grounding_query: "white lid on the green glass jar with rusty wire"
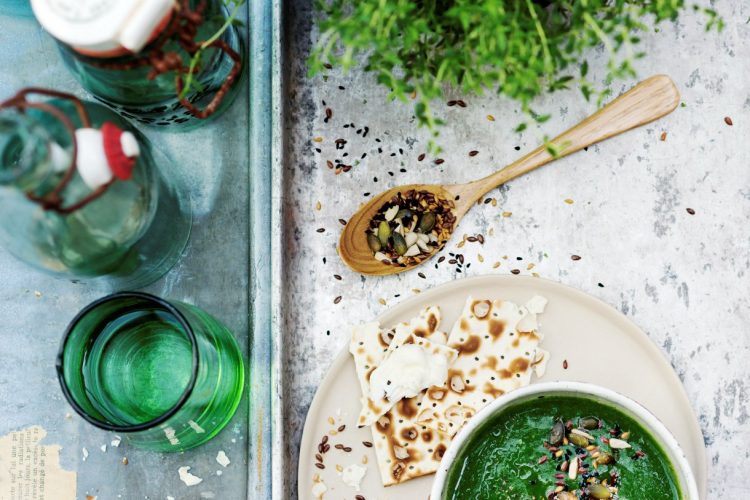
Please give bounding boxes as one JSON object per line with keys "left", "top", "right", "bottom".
{"left": 31, "top": 0, "right": 174, "bottom": 52}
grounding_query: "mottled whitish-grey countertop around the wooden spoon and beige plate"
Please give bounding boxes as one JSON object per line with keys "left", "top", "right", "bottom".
{"left": 282, "top": 0, "right": 750, "bottom": 499}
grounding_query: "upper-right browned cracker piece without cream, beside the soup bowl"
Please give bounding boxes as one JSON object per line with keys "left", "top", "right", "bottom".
{"left": 417, "top": 297, "right": 549, "bottom": 437}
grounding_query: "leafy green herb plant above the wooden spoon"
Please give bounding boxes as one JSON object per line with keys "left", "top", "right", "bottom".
{"left": 309, "top": 0, "right": 723, "bottom": 148}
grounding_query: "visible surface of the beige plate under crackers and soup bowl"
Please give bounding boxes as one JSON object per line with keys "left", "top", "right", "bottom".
{"left": 298, "top": 275, "right": 707, "bottom": 500}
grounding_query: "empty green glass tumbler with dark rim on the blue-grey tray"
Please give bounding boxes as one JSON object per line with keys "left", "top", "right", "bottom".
{"left": 57, "top": 292, "right": 244, "bottom": 451}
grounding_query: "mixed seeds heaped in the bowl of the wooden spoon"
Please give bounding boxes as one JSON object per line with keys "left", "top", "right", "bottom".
{"left": 366, "top": 189, "right": 456, "bottom": 267}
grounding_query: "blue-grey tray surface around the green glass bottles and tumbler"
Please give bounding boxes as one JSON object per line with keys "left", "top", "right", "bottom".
{"left": 0, "top": 14, "right": 250, "bottom": 500}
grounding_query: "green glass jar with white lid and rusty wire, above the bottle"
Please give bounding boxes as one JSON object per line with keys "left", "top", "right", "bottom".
{"left": 31, "top": 0, "right": 245, "bottom": 130}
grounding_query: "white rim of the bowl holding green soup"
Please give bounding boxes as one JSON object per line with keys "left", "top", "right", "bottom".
{"left": 430, "top": 382, "right": 699, "bottom": 500}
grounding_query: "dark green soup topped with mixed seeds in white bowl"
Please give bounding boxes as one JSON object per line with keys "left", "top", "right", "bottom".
{"left": 443, "top": 395, "right": 683, "bottom": 500}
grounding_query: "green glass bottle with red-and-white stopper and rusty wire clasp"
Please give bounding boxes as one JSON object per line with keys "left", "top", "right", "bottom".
{"left": 0, "top": 89, "right": 191, "bottom": 290}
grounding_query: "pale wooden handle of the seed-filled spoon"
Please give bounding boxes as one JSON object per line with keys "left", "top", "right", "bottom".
{"left": 476, "top": 75, "right": 680, "bottom": 200}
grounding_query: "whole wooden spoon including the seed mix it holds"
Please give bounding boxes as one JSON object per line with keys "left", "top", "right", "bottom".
{"left": 339, "top": 75, "right": 680, "bottom": 275}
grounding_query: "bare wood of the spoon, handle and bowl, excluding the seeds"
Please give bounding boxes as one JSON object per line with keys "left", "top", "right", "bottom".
{"left": 339, "top": 75, "right": 680, "bottom": 275}
